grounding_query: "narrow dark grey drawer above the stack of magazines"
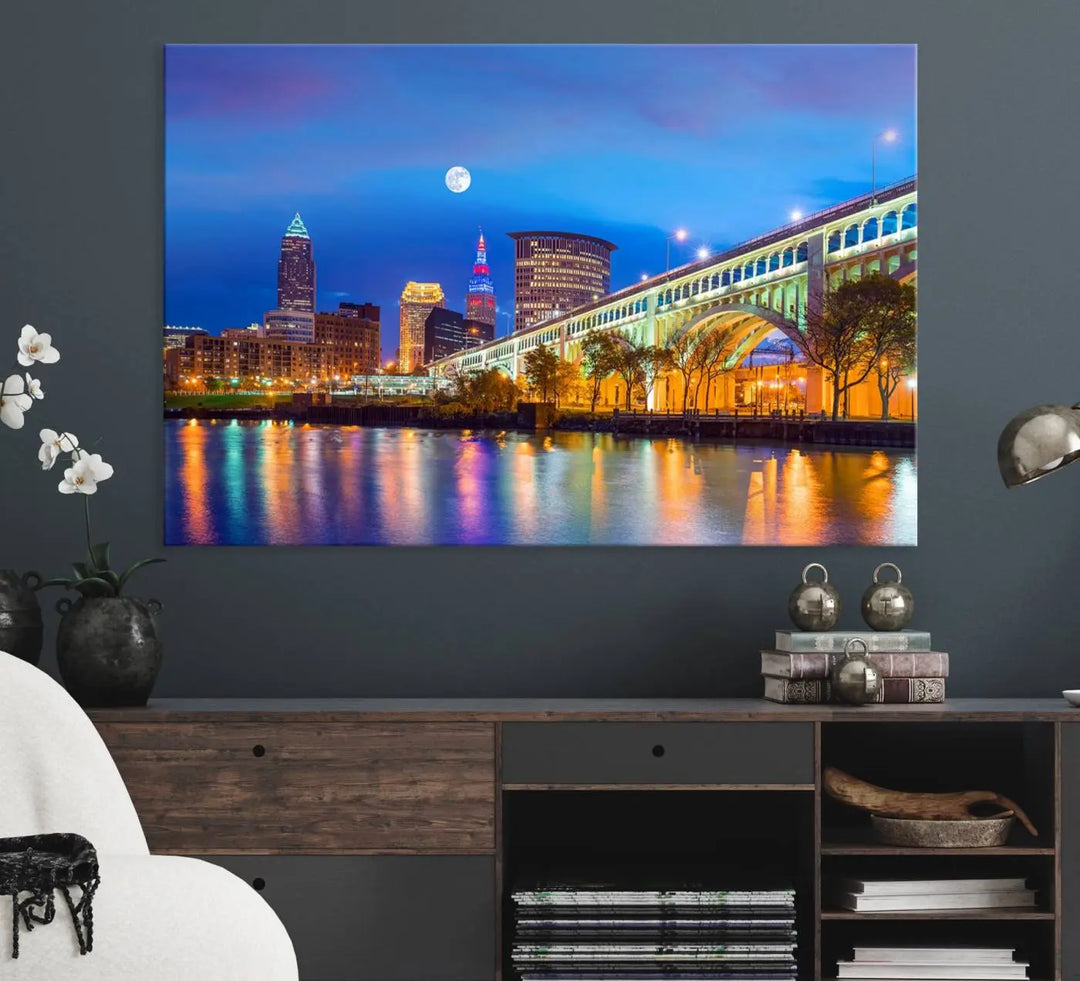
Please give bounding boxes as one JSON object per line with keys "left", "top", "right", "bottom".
{"left": 502, "top": 722, "right": 814, "bottom": 787}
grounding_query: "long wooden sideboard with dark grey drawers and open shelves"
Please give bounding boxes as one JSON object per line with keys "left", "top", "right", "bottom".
{"left": 91, "top": 699, "right": 1080, "bottom": 981}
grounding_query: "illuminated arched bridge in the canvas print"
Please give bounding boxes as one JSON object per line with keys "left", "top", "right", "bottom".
{"left": 428, "top": 177, "right": 918, "bottom": 411}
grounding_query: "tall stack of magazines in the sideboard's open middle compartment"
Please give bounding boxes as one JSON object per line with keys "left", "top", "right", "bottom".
{"left": 512, "top": 884, "right": 797, "bottom": 981}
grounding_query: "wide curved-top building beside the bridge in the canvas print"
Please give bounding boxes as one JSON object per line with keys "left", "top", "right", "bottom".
{"left": 509, "top": 231, "right": 619, "bottom": 331}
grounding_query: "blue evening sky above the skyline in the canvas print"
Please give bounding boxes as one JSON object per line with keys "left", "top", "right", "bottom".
{"left": 165, "top": 45, "right": 917, "bottom": 359}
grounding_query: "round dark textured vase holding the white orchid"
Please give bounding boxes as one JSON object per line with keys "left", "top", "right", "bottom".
{"left": 56, "top": 596, "right": 161, "bottom": 708}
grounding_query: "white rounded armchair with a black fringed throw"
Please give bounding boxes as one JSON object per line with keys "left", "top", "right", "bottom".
{"left": 0, "top": 653, "right": 297, "bottom": 981}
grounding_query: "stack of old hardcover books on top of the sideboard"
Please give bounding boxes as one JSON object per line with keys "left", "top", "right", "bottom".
{"left": 761, "top": 630, "right": 948, "bottom": 704}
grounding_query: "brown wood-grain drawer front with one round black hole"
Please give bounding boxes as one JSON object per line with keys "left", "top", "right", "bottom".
{"left": 98, "top": 721, "right": 496, "bottom": 855}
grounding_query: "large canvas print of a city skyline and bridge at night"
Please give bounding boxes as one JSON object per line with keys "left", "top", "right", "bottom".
{"left": 162, "top": 44, "right": 918, "bottom": 546}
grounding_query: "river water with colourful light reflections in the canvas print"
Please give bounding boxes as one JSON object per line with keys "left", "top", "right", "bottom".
{"left": 165, "top": 419, "right": 917, "bottom": 545}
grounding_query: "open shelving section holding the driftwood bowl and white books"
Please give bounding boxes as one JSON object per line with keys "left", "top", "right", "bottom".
{"left": 818, "top": 721, "right": 1057, "bottom": 979}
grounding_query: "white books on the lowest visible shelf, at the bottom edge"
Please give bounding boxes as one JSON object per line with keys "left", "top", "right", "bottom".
{"left": 837, "top": 946, "right": 1029, "bottom": 981}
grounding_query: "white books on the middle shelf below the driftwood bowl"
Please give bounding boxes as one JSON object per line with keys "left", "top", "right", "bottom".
{"left": 828, "top": 877, "right": 1035, "bottom": 913}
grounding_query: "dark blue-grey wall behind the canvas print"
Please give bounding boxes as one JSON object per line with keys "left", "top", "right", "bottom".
{"left": 0, "top": 0, "right": 1080, "bottom": 696}
